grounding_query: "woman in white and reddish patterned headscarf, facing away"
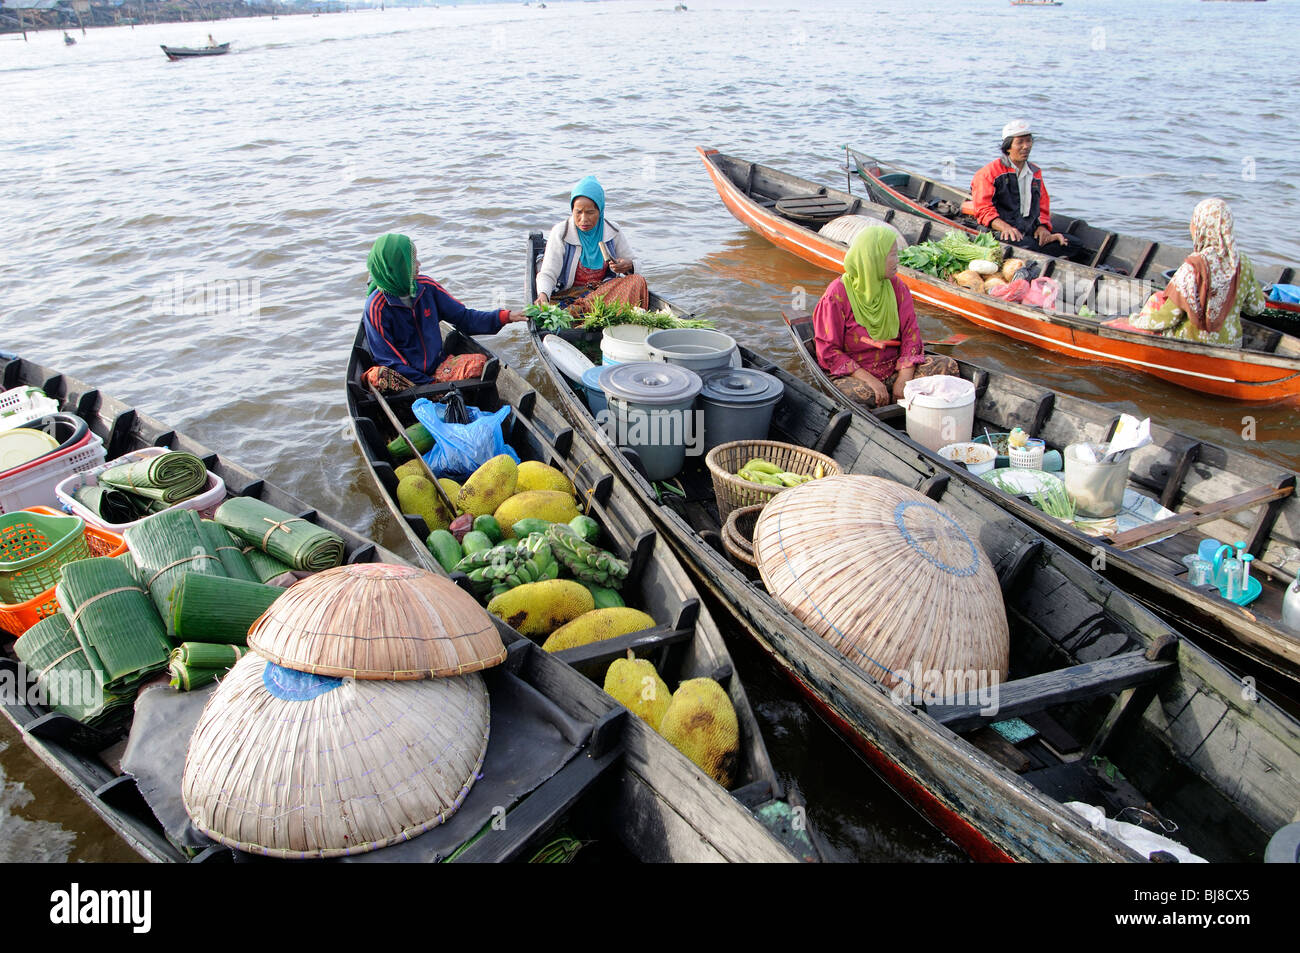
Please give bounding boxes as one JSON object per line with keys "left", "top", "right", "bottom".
{"left": 1121, "top": 199, "right": 1266, "bottom": 347}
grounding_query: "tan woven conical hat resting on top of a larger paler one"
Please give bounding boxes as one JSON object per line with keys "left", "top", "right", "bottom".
{"left": 248, "top": 563, "right": 506, "bottom": 679}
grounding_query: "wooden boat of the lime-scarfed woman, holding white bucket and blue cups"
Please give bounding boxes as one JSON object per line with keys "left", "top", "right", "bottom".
{"left": 785, "top": 316, "right": 1300, "bottom": 696}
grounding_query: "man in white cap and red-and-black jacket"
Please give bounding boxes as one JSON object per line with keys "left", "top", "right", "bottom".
{"left": 971, "top": 120, "right": 1069, "bottom": 255}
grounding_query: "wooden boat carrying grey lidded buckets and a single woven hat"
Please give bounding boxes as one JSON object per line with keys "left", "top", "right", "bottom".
{"left": 512, "top": 233, "right": 1300, "bottom": 861}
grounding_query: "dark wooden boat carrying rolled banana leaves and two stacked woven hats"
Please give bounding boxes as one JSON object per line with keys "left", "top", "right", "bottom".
{"left": 0, "top": 355, "right": 794, "bottom": 862}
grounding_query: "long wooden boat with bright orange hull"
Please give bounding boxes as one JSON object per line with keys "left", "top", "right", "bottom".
{"left": 699, "top": 148, "right": 1300, "bottom": 403}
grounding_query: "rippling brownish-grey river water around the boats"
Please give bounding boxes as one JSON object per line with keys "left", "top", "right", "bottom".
{"left": 0, "top": 0, "right": 1300, "bottom": 861}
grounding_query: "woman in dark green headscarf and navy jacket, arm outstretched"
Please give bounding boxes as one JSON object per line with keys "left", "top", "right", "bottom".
{"left": 361, "top": 234, "right": 525, "bottom": 390}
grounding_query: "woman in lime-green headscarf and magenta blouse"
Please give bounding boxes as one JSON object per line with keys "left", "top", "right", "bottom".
{"left": 813, "top": 225, "right": 958, "bottom": 407}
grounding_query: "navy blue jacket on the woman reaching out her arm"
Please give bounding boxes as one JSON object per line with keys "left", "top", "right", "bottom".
{"left": 363, "top": 274, "right": 510, "bottom": 384}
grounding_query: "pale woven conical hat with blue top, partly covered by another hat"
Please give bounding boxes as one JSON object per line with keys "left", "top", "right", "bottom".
{"left": 181, "top": 655, "right": 488, "bottom": 858}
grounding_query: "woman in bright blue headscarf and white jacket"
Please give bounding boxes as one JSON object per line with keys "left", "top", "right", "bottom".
{"left": 537, "top": 176, "right": 650, "bottom": 313}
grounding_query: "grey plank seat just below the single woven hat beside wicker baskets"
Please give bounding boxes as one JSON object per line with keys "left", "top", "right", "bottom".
{"left": 926, "top": 650, "right": 1175, "bottom": 733}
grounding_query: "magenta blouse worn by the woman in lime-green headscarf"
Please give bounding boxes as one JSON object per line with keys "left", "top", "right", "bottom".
{"left": 813, "top": 276, "right": 926, "bottom": 381}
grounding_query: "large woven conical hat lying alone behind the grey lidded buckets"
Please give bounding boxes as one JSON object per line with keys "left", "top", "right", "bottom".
{"left": 754, "top": 476, "right": 1010, "bottom": 694}
